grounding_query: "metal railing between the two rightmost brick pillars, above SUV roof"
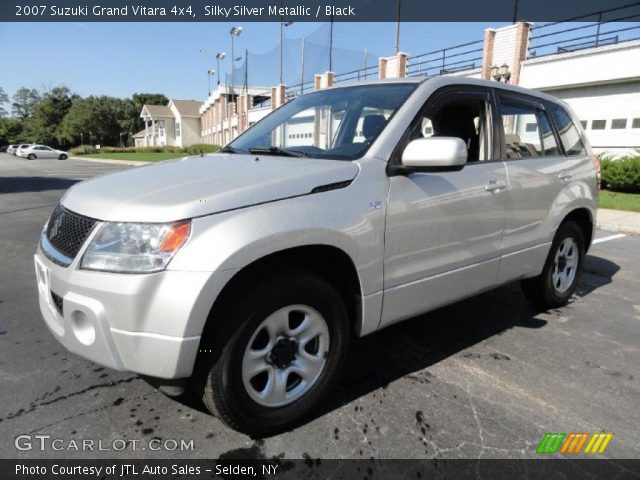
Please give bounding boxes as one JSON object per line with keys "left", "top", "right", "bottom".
{"left": 407, "top": 40, "right": 483, "bottom": 77}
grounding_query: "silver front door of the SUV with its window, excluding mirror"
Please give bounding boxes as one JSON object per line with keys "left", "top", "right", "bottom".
{"left": 381, "top": 87, "right": 508, "bottom": 327}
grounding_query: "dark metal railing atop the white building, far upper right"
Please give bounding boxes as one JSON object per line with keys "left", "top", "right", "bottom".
{"left": 527, "top": 2, "right": 640, "bottom": 58}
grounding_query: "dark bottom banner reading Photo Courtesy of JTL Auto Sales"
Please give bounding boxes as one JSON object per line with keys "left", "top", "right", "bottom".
{"left": 0, "top": 457, "right": 640, "bottom": 480}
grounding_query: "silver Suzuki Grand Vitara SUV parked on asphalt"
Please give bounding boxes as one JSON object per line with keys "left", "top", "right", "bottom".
{"left": 35, "top": 77, "right": 599, "bottom": 435}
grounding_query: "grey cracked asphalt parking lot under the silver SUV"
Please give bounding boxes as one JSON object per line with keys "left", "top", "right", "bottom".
{"left": 0, "top": 154, "right": 640, "bottom": 459}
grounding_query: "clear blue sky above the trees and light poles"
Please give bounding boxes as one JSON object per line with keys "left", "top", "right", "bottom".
{"left": 0, "top": 22, "right": 505, "bottom": 100}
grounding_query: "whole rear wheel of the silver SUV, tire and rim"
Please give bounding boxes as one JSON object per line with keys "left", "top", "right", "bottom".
{"left": 522, "top": 221, "right": 585, "bottom": 309}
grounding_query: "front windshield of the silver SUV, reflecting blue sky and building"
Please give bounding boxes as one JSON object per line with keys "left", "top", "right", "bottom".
{"left": 228, "top": 83, "right": 416, "bottom": 160}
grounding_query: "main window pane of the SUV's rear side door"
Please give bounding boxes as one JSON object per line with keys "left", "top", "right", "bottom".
{"left": 500, "top": 99, "right": 553, "bottom": 159}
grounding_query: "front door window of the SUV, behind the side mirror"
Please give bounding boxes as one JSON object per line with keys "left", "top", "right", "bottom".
{"left": 409, "top": 93, "right": 489, "bottom": 162}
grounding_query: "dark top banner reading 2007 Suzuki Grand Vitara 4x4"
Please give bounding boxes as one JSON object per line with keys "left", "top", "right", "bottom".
{"left": 0, "top": 0, "right": 640, "bottom": 22}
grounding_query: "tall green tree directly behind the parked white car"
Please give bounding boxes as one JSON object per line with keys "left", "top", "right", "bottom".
{"left": 25, "top": 86, "right": 79, "bottom": 146}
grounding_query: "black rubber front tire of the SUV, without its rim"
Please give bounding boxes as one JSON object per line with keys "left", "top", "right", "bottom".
{"left": 195, "top": 271, "right": 350, "bottom": 437}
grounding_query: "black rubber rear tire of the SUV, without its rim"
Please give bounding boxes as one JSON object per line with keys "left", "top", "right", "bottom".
{"left": 522, "top": 220, "right": 585, "bottom": 310}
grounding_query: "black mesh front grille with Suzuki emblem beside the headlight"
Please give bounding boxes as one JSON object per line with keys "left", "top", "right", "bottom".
{"left": 46, "top": 205, "right": 96, "bottom": 259}
